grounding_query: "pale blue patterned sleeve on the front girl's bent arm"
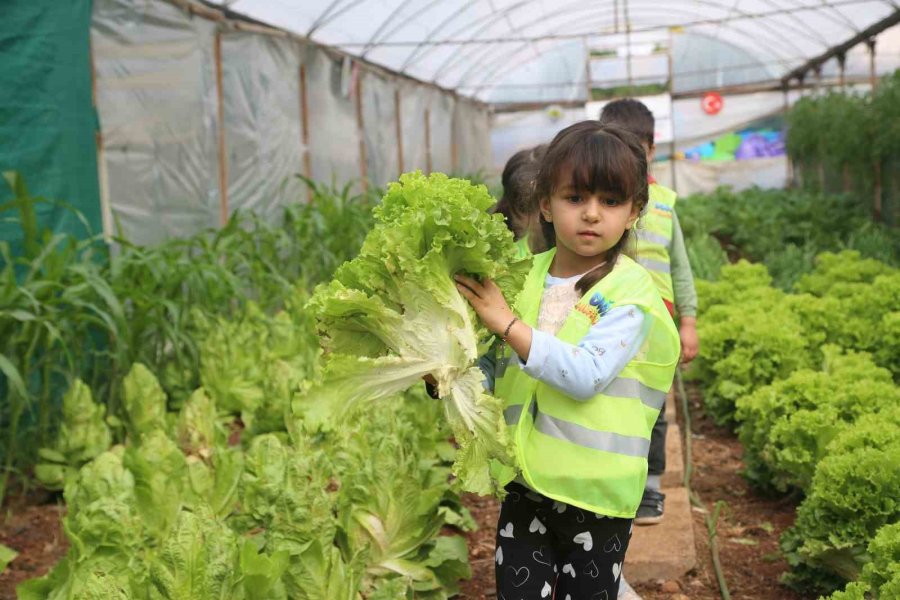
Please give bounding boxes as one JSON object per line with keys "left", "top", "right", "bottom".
{"left": 519, "top": 305, "right": 649, "bottom": 400}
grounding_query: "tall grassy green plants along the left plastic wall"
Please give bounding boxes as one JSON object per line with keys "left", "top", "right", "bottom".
{"left": 0, "top": 170, "right": 378, "bottom": 502}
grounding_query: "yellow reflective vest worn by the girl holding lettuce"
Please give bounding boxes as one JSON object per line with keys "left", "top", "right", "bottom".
{"left": 495, "top": 248, "right": 680, "bottom": 518}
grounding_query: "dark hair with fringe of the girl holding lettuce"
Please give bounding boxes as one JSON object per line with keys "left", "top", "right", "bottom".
{"left": 535, "top": 121, "right": 649, "bottom": 294}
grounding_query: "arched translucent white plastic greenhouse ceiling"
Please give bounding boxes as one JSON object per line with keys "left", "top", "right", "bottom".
{"left": 209, "top": 0, "right": 900, "bottom": 101}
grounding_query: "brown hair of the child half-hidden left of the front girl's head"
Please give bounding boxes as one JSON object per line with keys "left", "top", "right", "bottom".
{"left": 494, "top": 144, "right": 547, "bottom": 239}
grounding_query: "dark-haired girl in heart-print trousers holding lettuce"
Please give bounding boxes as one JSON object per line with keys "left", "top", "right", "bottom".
{"left": 456, "top": 121, "right": 679, "bottom": 600}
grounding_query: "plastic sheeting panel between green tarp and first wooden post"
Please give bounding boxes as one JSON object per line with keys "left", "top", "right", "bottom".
{"left": 91, "top": 0, "right": 220, "bottom": 244}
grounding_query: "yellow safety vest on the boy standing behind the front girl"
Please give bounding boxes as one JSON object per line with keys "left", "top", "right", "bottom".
{"left": 634, "top": 183, "right": 677, "bottom": 304}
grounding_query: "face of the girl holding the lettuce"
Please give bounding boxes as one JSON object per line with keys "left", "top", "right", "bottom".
{"left": 541, "top": 184, "right": 639, "bottom": 264}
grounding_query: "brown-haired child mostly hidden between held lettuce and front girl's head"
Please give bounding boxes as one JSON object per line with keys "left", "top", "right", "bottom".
{"left": 494, "top": 144, "right": 547, "bottom": 257}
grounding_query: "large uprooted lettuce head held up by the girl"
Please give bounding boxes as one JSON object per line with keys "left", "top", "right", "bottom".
{"left": 293, "top": 172, "right": 529, "bottom": 494}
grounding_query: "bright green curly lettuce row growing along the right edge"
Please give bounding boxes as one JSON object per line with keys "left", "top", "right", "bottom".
{"left": 690, "top": 250, "right": 900, "bottom": 599}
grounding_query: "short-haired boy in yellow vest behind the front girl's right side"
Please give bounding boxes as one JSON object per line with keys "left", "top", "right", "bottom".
{"left": 600, "top": 98, "right": 700, "bottom": 525}
